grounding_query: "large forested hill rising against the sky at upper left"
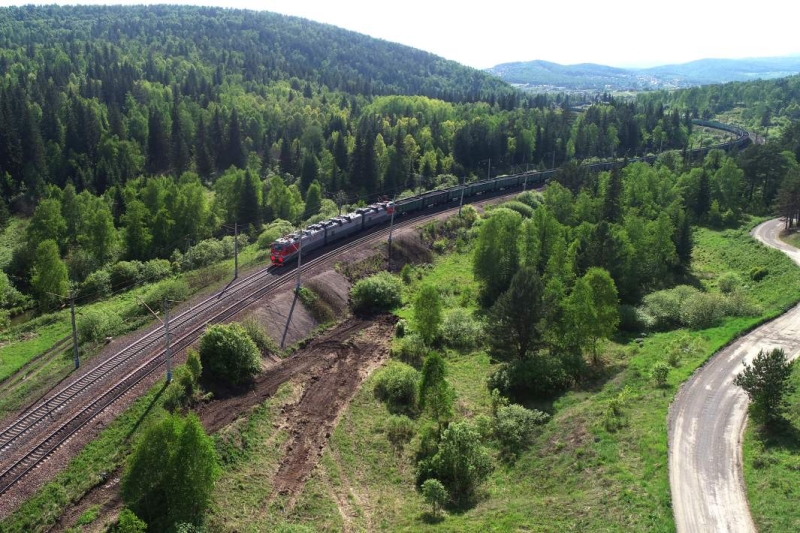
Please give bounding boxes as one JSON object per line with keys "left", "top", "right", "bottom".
{"left": 0, "top": 6, "right": 513, "bottom": 101}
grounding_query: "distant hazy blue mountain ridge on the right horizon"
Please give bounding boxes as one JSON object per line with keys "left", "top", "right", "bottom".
{"left": 486, "top": 56, "right": 800, "bottom": 90}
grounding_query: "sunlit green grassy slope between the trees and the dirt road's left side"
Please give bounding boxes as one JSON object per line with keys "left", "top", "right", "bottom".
{"left": 270, "top": 222, "right": 800, "bottom": 531}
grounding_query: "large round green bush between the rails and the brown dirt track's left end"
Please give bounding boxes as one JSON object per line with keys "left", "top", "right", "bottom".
{"left": 200, "top": 324, "right": 261, "bottom": 385}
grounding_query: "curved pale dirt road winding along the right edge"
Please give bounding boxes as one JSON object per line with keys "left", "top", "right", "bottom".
{"left": 668, "top": 220, "right": 800, "bottom": 533}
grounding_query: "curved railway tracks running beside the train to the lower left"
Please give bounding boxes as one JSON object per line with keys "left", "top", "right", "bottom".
{"left": 0, "top": 119, "right": 749, "bottom": 502}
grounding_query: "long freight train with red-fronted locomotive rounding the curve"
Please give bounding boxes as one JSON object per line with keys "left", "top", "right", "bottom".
{"left": 270, "top": 120, "right": 750, "bottom": 266}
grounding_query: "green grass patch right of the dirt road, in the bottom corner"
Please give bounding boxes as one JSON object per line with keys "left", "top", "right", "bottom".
{"left": 743, "top": 364, "right": 800, "bottom": 533}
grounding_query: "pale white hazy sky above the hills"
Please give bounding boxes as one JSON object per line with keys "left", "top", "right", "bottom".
{"left": 0, "top": 0, "right": 800, "bottom": 68}
